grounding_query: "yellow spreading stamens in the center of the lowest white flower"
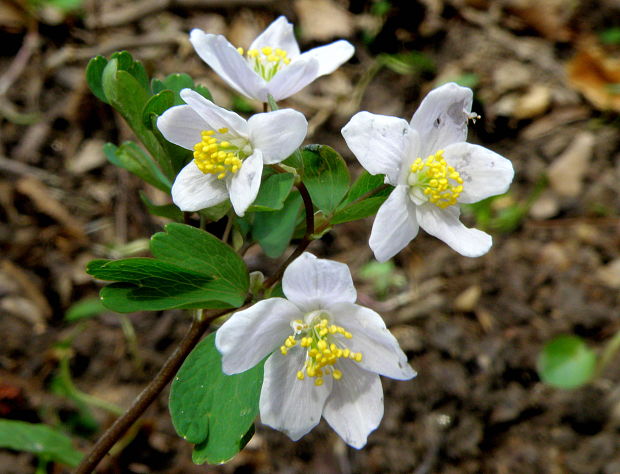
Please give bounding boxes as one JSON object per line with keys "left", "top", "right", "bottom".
{"left": 280, "top": 311, "right": 362, "bottom": 385}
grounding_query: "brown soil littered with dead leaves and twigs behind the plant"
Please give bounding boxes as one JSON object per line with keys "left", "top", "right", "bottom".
{"left": 0, "top": 0, "right": 620, "bottom": 474}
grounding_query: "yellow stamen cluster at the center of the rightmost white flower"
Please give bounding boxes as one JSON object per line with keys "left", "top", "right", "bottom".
{"left": 407, "top": 150, "right": 463, "bottom": 209}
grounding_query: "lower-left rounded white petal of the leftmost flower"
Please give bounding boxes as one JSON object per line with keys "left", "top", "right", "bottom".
{"left": 172, "top": 160, "right": 228, "bottom": 212}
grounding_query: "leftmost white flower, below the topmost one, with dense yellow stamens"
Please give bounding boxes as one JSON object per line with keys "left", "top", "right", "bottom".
{"left": 157, "top": 89, "right": 308, "bottom": 216}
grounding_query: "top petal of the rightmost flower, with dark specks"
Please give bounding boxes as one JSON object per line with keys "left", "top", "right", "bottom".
{"left": 411, "top": 82, "right": 473, "bottom": 158}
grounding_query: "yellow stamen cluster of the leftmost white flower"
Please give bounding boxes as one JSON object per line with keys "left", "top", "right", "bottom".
{"left": 194, "top": 128, "right": 245, "bottom": 179}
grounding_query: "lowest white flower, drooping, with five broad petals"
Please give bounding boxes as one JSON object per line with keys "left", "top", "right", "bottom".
{"left": 215, "top": 253, "right": 415, "bottom": 449}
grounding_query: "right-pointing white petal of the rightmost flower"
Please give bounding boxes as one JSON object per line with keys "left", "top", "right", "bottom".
{"left": 444, "top": 142, "right": 515, "bottom": 203}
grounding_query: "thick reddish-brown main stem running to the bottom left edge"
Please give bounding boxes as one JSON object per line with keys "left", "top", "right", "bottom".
{"left": 75, "top": 309, "right": 231, "bottom": 474}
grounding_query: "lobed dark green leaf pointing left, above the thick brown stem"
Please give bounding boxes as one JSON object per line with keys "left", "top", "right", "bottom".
{"left": 86, "top": 223, "right": 249, "bottom": 313}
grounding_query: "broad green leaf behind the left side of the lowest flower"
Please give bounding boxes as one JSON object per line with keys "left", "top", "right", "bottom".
{"left": 169, "top": 334, "right": 263, "bottom": 464}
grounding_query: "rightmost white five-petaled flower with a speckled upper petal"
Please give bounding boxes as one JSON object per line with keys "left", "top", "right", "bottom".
{"left": 342, "top": 83, "right": 514, "bottom": 262}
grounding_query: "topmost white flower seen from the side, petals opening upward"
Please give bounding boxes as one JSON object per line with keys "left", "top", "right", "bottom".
{"left": 190, "top": 16, "right": 355, "bottom": 102}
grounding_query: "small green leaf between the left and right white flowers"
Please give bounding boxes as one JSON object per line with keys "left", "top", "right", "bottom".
{"left": 301, "top": 145, "right": 349, "bottom": 214}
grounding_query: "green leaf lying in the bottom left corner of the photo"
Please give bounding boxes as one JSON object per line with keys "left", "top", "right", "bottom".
{"left": 0, "top": 420, "right": 83, "bottom": 467}
